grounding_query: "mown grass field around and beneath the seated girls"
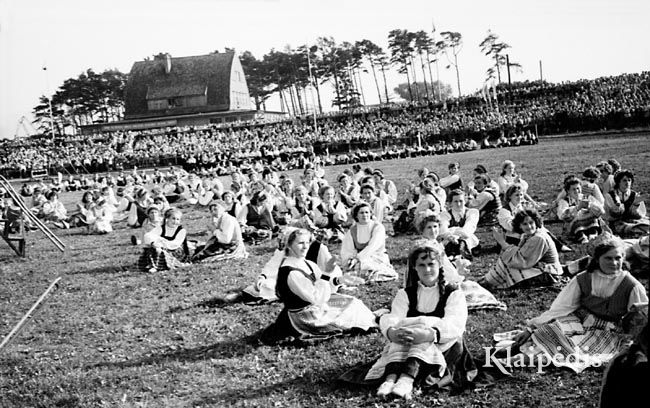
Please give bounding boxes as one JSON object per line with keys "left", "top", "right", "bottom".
{"left": 0, "top": 133, "right": 650, "bottom": 408}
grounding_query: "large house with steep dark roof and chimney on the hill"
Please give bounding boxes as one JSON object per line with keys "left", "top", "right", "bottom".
{"left": 82, "top": 52, "right": 285, "bottom": 133}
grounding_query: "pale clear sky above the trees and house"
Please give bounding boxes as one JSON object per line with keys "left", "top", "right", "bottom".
{"left": 0, "top": 0, "right": 650, "bottom": 138}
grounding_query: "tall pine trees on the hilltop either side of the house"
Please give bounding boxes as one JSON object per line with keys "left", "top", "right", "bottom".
{"left": 33, "top": 28, "right": 521, "bottom": 134}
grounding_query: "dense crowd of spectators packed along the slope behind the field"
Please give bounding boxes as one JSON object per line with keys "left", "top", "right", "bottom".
{"left": 0, "top": 72, "right": 650, "bottom": 177}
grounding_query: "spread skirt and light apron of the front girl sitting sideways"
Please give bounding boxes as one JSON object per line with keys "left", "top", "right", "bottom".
{"left": 261, "top": 293, "right": 377, "bottom": 344}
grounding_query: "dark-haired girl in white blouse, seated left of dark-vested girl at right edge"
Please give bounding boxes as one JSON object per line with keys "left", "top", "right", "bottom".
{"left": 557, "top": 176, "right": 605, "bottom": 244}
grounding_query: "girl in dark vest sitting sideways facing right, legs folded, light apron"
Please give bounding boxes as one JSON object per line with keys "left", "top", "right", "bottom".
{"left": 261, "top": 229, "right": 377, "bottom": 343}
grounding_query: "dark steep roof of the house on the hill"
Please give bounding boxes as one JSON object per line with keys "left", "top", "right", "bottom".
{"left": 124, "top": 52, "right": 235, "bottom": 119}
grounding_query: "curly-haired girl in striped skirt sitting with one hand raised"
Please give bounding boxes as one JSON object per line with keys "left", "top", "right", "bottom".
{"left": 479, "top": 209, "right": 563, "bottom": 289}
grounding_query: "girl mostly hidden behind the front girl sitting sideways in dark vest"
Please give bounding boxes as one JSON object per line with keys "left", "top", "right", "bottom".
{"left": 243, "top": 227, "right": 344, "bottom": 302}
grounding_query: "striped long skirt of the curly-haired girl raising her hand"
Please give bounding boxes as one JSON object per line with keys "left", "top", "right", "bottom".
{"left": 479, "top": 257, "right": 562, "bottom": 289}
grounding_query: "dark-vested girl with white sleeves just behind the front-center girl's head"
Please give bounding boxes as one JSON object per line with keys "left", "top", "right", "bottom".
{"left": 440, "top": 190, "right": 479, "bottom": 260}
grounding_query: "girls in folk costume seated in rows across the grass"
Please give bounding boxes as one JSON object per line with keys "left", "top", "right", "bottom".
{"left": 3, "top": 154, "right": 650, "bottom": 399}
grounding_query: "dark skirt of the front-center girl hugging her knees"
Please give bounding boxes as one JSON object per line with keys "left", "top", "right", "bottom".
{"left": 338, "top": 339, "right": 478, "bottom": 391}
